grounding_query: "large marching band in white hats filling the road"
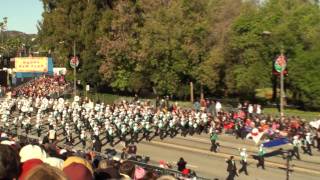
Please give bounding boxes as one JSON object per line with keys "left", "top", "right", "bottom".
{"left": 1, "top": 97, "right": 212, "bottom": 150}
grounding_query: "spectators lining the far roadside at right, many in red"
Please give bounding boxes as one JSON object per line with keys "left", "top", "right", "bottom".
{"left": 194, "top": 100, "right": 320, "bottom": 151}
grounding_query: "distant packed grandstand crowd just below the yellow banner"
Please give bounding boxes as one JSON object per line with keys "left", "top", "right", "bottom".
{"left": 12, "top": 75, "right": 68, "bottom": 97}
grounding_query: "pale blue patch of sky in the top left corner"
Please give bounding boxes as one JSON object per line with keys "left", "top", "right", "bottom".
{"left": 0, "top": 0, "right": 43, "bottom": 34}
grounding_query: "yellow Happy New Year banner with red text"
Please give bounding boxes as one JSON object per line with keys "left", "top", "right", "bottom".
{"left": 15, "top": 57, "right": 48, "bottom": 73}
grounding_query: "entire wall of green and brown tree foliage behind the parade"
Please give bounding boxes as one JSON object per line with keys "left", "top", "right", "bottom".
{"left": 39, "top": 0, "right": 320, "bottom": 107}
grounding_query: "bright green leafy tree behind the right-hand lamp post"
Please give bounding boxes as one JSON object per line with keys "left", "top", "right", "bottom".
{"left": 226, "top": 0, "right": 320, "bottom": 105}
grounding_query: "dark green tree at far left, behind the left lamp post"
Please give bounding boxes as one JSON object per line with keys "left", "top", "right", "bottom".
{"left": 39, "top": 0, "right": 108, "bottom": 88}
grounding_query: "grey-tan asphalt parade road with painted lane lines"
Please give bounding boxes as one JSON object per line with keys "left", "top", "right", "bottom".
{"left": 0, "top": 109, "right": 320, "bottom": 180}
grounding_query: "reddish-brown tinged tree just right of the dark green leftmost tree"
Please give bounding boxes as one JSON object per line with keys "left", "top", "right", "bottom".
{"left": 98, "top": 1, "right": 146, "bottom": 91}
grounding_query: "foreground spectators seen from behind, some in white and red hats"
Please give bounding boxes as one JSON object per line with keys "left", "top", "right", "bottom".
{"left": 0, "top": 132, "right": 198, "bottom": 180}
